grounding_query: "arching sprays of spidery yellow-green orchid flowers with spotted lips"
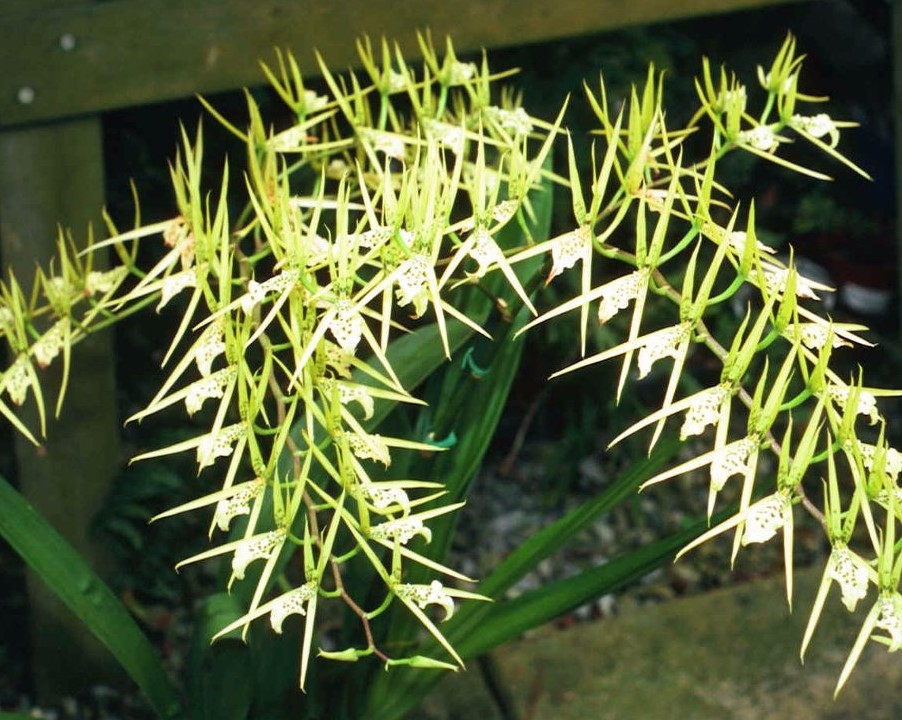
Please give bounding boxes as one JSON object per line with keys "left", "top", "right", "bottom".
{"left": 0, "top": 36, "right": 902, "bottom": 690}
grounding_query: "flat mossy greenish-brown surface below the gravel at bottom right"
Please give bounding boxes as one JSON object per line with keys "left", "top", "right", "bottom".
{"left": 409, "top": 569, "right": 902, "bottom": 720}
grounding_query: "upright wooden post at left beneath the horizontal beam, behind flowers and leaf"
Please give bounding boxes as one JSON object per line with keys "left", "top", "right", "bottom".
{"left": 0, "top": 28, "right": 120, "bottom": 702}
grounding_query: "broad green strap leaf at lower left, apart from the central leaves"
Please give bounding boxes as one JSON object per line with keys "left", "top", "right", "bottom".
{"left": 0, "top": 477, "right": 181, "bottom": 718}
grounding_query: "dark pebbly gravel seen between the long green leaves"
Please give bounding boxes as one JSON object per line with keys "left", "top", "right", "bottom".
{"left": 455, "top": 434, "right": 827, "bottom": 624}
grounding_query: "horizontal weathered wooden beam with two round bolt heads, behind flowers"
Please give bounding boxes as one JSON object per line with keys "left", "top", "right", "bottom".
{"left": 0, "top": 0, "right": 803, "bottom": 127}
